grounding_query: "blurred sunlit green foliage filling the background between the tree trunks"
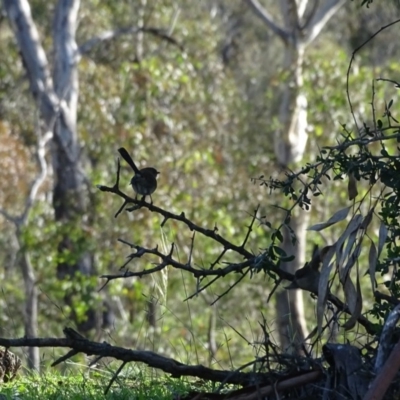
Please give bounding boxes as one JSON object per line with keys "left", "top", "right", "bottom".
{"left": 0, "top": 1, "right": 400, "bottom": 376}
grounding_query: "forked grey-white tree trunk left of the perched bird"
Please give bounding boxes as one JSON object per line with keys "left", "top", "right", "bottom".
{"left": 3, "top": 0, "right": 99, "bottom": 338}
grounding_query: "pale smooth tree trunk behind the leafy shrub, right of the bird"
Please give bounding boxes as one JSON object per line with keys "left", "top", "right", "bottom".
{"left": 245, "top": 0, "right": 345, "bottom": 350}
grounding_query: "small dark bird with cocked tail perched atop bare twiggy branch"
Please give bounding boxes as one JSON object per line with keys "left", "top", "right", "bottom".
{"left": 118, "top": 147, "right": 159, "bottom": 201}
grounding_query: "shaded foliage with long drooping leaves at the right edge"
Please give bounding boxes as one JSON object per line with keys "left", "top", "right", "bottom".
{"left": 265, "top": 81, "right": 400, "bottom": 333}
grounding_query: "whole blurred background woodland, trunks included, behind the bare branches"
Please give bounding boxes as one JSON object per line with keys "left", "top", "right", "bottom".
{"left": 0, "top": 0, "right": 400, "bottom": 378}
